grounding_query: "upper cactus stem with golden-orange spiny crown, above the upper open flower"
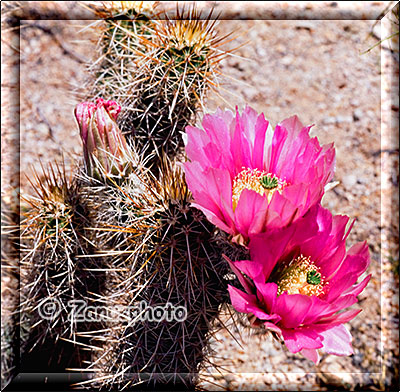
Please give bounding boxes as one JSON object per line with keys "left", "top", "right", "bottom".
{"left": 121, "top": 4, "right": 233, "bottom": 170}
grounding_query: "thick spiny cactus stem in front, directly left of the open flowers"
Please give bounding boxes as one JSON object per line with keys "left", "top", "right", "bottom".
{"left": 77, "top": 157, "right": 236, "bottom": 389}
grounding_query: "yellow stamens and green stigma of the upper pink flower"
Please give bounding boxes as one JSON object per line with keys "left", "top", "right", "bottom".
{"left": 232, "top": 168, "right": 287, "bottom": 211}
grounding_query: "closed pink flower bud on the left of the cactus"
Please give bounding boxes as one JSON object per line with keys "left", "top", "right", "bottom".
{"left": 75, "top": 98, "right": 127, "bottom": 178}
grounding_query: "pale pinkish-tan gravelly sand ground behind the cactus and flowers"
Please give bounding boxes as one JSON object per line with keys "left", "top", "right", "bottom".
{"left": 1, "top": 1, "right": 399, "bottom": 390}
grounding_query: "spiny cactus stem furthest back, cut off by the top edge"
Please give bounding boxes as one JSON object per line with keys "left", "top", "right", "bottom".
{"left": 83, "top": 1, "right": 157, "bottom": 101}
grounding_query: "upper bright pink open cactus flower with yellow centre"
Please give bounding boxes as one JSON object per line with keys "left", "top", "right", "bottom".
{"left": 184, "top": 106, "right": 335, "bottom": 241}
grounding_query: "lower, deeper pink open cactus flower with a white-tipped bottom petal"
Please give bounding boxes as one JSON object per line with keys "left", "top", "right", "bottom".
{"left": 227, "top": 205, "right": 370, "bottom": 363}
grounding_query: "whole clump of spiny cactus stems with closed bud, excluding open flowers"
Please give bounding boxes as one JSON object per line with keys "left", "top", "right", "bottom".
{"left": 15, "top": 2, "right": 239, "bottom": 390}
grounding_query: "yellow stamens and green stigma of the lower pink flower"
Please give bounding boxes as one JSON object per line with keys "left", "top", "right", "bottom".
{"left": 277, "top": 255, "right": 328, "bottom": 297}
